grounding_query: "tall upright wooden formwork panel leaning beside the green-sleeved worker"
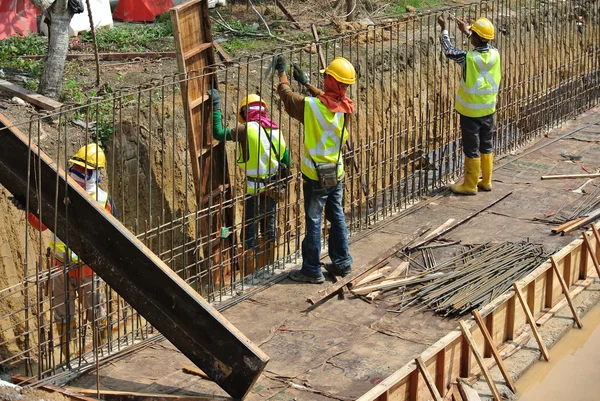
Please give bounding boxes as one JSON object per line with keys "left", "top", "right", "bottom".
{"left": 171, "top": 0, "right": 235, "bottom": 285}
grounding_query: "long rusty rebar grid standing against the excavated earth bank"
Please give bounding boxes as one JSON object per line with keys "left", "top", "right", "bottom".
{"left": 0, "top": 0, "right": 600, "bottom": 380}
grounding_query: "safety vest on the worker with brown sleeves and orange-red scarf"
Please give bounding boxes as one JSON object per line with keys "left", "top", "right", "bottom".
{"left": 301, "top": 97, "right": 348, "bottom": 181}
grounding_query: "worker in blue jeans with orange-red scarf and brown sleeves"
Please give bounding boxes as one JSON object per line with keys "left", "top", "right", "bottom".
{"left": 274, "top": 56, "right": 356, "bottom": 284}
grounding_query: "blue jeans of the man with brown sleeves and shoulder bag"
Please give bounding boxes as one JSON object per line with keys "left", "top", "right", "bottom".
{"left": 302, "top": 178, "right": 352, "bottom": 277}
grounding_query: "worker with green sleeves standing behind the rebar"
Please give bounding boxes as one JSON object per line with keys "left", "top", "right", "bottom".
{"left": 208, "top": 89, "right": 291, "bottom": 275}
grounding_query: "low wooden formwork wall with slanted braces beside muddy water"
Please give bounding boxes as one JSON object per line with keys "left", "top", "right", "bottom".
{"left": 358, "top": 234, "right": 600, "bottom": 401}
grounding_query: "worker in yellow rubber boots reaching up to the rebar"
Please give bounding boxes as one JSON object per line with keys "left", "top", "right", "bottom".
{"left": 438, "top": 16, "right": 501, "bottom": 195}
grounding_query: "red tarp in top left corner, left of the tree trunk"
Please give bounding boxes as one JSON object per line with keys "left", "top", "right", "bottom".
{"left": 0, "top": 0, "right": 40, "bottom": 39}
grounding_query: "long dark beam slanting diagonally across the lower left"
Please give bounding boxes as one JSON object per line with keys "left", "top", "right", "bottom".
{"left": 0, "top": 115, "right": 269, "bottom": 398}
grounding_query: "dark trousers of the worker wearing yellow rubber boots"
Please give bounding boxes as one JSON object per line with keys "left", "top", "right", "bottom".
{"left": 460, "top": 114, "right": 494, "bottom": 159}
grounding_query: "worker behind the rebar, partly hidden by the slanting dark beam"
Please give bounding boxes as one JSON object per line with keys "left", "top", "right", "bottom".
{"left": 11, "top": 143, "right": 118, "bottom": 362}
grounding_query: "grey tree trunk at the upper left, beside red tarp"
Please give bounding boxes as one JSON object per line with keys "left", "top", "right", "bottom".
{"left": 38, "top": 0, "right": 73, "bottom": 99}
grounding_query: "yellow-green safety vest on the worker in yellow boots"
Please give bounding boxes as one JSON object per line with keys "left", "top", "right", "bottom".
{"left": 455, "top": 48, "right": 502, "bottom": 117}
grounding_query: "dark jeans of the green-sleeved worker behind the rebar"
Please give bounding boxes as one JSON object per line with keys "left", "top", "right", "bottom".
{"left": 244, "top": 193, "right": 277, "bottom": 249}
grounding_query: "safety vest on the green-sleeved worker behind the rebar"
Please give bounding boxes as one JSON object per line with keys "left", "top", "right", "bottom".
{"left": 237, "top": 121, "right": 286, "bottom": 194}
